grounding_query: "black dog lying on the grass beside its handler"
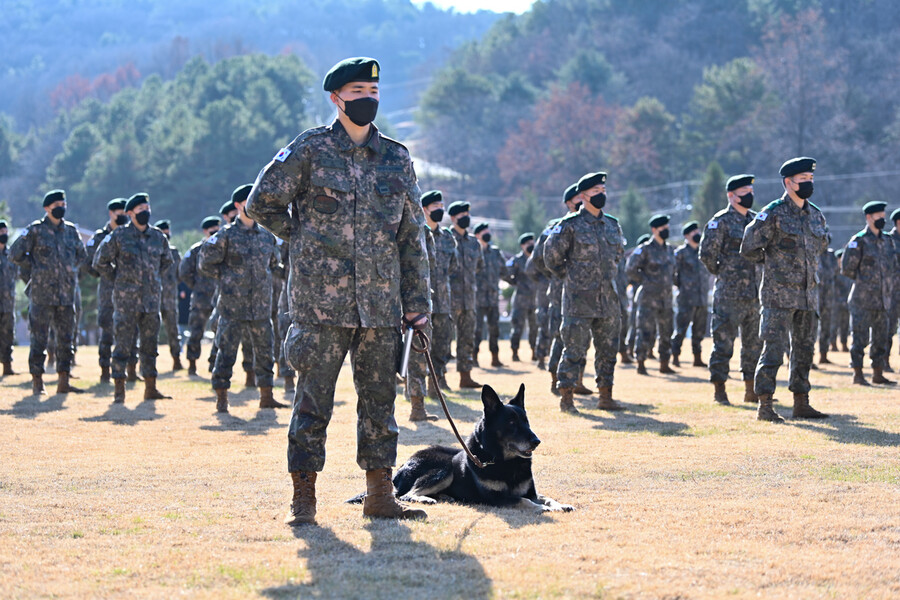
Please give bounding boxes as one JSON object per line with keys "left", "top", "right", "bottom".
{"left": 349, "top": 384, "right": 574, "bottom": 512}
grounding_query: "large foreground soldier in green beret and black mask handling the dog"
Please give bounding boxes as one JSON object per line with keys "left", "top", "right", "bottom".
{"left": 247, "top": 58, "right": 430, "bottom": 525}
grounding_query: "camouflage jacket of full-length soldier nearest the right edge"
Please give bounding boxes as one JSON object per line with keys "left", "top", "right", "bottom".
{"left": 841, "top": 227, "right": 897, "bottom": 310}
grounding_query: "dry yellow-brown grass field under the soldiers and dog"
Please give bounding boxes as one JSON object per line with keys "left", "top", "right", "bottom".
{"left": 0, "top": 340, "right": 900, "bottom": 599}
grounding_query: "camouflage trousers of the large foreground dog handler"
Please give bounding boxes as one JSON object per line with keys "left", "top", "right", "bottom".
{"left": 284, "top": 322, "right": 400, "bottom": 472}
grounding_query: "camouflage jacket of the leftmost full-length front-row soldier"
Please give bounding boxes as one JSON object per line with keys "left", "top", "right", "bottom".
{"left": 9, "top": 216, "right": 86, "bottom": 306}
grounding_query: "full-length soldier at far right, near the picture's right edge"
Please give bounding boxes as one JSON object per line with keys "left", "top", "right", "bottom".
{"left": 841, "top": 202, "right": 897, "bottom": 386}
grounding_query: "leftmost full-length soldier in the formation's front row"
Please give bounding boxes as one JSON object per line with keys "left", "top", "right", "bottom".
{"left": 9, "top": 190, "right": 86, "bottom": 395}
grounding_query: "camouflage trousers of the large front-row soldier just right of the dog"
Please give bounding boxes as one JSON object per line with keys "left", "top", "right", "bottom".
{"left": 556, "top": 311, "right": 621, "bottom": 389}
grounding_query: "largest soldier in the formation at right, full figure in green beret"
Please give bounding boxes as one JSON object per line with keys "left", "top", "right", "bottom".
{"left": 741, "top": 157, "right": 828, "bottom": 423}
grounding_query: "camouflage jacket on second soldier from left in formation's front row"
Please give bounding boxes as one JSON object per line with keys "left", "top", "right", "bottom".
{"left": 92, "top": 223, "right": 172, "bottom": 313}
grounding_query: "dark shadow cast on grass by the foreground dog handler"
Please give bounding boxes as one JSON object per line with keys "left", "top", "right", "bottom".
{"left": 260, "top": 519, "right": 491, "bottom": 599}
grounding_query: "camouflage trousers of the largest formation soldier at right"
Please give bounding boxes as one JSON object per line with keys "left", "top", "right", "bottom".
{"left": 753, "top": 308, "right": 818, "bottom": 394}
